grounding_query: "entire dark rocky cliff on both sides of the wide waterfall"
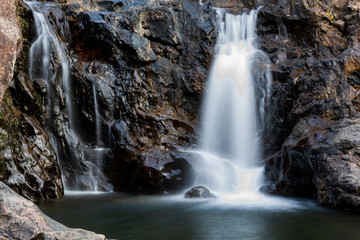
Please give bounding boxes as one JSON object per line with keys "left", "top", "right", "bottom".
{"left": 3, "top": 0, "right": 360, "bottom": 213}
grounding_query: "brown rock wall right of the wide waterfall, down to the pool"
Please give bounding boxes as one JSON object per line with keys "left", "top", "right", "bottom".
{"left": 249, "top": 1, "right": 360, "bottom": 210}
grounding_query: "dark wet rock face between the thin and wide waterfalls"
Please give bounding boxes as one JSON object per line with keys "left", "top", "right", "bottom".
{"left": 59, "top": 1, "right": 216, "bottom": 192}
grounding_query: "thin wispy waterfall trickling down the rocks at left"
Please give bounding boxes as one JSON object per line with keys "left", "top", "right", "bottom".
{"left": 24, "top": 1, "right": 112, "bottom": 192}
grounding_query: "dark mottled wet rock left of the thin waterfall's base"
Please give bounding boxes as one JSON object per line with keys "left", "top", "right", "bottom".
{"left": 0, "top": 91, "right": 64, "bottom": 200}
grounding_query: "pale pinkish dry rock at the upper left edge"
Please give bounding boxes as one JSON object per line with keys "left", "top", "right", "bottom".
{"left": 0, "top": 0, "right": 21, "bottom": 102}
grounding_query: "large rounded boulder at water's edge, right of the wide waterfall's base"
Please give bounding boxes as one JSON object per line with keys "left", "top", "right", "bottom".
{"left": 265, "top": 118, "right": 360, "bottom": 211}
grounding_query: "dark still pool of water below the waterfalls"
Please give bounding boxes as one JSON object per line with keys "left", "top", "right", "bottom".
{"left": 38, "top": 193, "right": 360, "bottom": 240}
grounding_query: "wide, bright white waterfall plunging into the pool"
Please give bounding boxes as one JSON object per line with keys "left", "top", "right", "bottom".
{"left": 196, "top": 9, "right": 271, "bottom": 200}
